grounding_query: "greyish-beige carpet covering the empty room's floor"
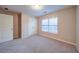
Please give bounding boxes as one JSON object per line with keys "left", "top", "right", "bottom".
{"left": 0, "top": 35, "right": 77, "bottom": 53}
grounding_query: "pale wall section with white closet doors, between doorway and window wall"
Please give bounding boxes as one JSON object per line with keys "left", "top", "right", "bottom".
{"left": 21, "top": 13, "right": 37, "bottom": 38}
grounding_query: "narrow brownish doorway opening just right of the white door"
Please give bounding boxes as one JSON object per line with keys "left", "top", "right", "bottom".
{"left": 13, "top": 14, "right": 21, "bottom": 39}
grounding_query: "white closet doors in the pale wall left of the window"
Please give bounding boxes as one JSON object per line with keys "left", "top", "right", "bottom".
{"left": 28, "top": 17, "right": 37, "bottom": 36}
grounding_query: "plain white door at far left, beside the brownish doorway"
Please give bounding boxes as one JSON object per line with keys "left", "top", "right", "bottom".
{"left": 0, "top": 14, "right": 13, "bottom": 43}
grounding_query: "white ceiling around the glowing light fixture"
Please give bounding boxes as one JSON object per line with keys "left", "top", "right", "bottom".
{"left": 0, "top": 5, "right": 72, "bottom": 16}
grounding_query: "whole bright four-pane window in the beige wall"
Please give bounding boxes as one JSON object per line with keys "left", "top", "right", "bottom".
{"left": 42, "top": 17, "right": 58, "bottom": 33}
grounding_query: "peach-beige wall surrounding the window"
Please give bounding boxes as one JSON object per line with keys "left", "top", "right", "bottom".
{"left": 38, "top": 7, "right": 76, "bottom": 45}
